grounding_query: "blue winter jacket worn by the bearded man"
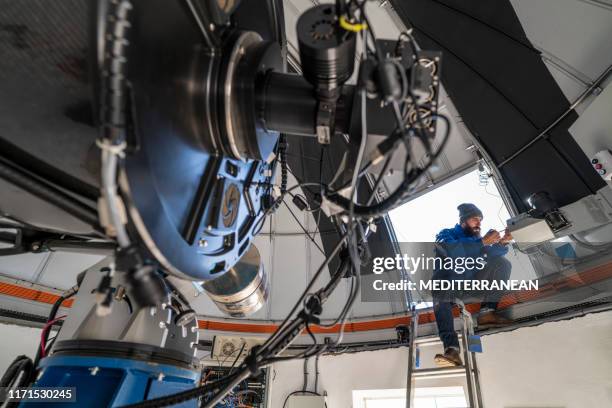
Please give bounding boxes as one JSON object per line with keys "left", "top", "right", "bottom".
{"left": 436, "top": 224, "right": 508, "bottom": 278}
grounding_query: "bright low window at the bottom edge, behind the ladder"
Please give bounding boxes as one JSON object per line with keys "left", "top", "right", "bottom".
{"left": 353, "top": 387, "right": 468, "bottom": 408}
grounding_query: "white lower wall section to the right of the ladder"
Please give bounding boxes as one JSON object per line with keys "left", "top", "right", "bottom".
{"left": 479, "top": 312, "right": 612, "bottom": 408}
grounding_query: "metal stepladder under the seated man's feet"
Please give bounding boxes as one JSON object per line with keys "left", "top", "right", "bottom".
{"left": 406, "top": 300, "right": 484, "bottom": 408}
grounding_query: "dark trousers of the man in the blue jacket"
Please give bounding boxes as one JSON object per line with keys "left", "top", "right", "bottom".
{"left": 433, "top": 256, "right": 512, "bottom": 350}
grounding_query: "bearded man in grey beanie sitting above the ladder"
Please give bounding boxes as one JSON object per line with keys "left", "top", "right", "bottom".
{"left": 433, "top": 203, "right": 512, "bottom": 367}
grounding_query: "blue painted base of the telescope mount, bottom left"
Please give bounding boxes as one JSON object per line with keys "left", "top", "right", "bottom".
{"left": 20, "top": 356, "right": 200, "bottom": 408}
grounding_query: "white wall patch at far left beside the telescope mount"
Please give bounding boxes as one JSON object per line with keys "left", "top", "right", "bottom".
{"left": 0, "top": 323, "right": 41, "bottom": 376}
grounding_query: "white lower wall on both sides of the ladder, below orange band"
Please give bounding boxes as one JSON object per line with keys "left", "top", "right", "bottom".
{"left": 269, "top": 312, "right": 612, "bottom": 408}
